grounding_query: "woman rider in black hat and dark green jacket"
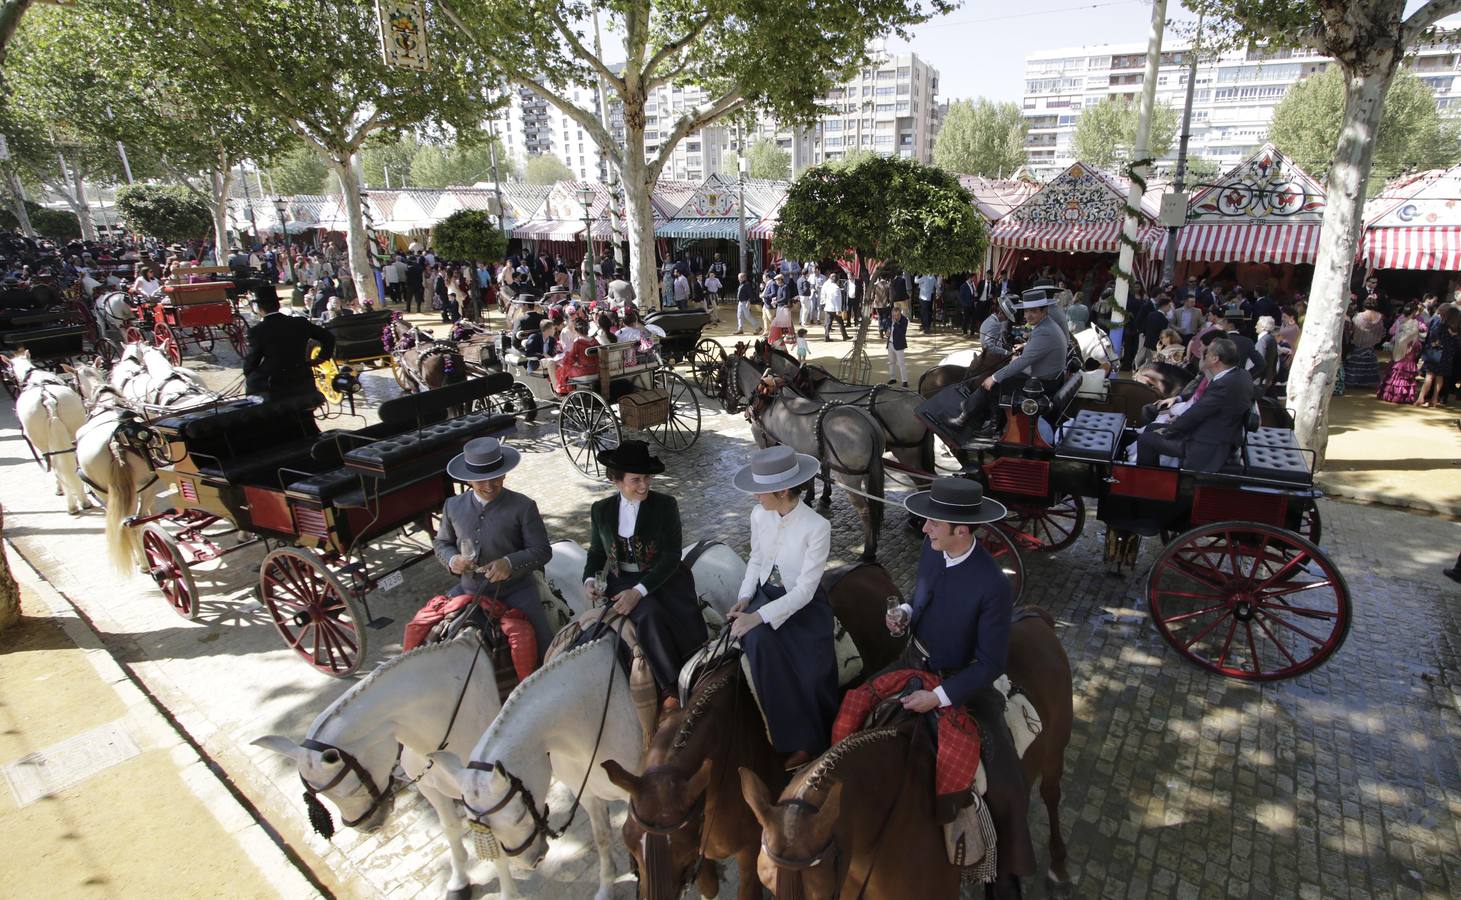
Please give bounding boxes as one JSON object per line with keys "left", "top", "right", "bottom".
{"left": 583, "top": 440, "right": 707, "bottom": 706}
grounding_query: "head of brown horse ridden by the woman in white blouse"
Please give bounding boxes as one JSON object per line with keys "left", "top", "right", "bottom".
{"left": 603, "top": 753, "right": 710, "bottom": 900}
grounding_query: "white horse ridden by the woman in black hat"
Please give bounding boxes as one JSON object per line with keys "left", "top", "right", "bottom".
{"left": 431, "top": 636, "right": 646, "bottom": 900}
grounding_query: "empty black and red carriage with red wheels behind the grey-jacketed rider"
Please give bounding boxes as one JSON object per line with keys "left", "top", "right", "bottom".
{"left": 129, "top": 375, "right": 514, "bottom": 676}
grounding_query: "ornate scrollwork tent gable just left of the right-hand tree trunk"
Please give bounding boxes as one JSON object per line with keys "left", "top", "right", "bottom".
{"left": 1188, "top": 143, "right": 1324, "bottom": 224}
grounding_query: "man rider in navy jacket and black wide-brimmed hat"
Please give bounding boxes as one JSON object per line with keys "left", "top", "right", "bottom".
{"left": 887, "top": 478, "right": 1034, "bottom": 875}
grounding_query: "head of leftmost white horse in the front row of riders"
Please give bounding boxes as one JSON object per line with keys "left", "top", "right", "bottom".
{"left": 253, "top": 733, "right": 397, "bottom": 839}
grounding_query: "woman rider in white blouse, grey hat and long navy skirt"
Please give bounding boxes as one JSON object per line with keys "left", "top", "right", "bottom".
{"left": 731, "top": 446, "right": 837, "bottom": 769}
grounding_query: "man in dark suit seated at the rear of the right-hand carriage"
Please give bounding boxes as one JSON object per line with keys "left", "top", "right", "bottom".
{"left": 1137, "top": 338, "right": 1254, "bottom": 472}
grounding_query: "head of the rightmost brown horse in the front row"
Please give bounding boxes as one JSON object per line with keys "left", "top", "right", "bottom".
{"left": 741, "top": 769, "right": 842, "bottom": 900}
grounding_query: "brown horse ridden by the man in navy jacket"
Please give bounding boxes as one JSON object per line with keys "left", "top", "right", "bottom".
{"left": 741, "top": 612, "right": 1074, "bottom": 900}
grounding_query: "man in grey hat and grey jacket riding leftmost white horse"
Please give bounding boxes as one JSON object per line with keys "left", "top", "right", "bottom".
{"left": 408, "top": 437, "right": 554, "bottom": 659}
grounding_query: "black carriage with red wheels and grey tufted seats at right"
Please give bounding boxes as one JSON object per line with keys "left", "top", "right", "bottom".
{"left": 919, "top": 374, "right": 1350, "bottom": 681}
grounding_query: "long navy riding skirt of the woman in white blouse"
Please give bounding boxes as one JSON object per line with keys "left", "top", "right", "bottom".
{"left": 741, "top": 584, "right": 837, "bottom": 755}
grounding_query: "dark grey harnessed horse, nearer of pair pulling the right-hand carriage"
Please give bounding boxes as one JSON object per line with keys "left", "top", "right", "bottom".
{"left": 723, "top": 355, "right": 885, "bottom": 563}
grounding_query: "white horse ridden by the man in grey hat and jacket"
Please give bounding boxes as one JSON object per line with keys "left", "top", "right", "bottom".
{"left": 254, "top": 634, "right": 516, "bottom": 900}
